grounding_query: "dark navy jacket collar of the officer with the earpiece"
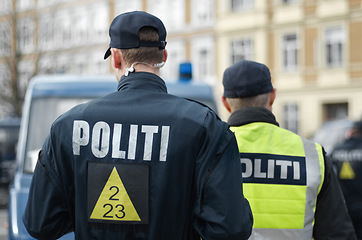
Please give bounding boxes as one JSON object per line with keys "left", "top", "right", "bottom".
{"left": 117, "top": 72, "right": 167, "bottom": 93}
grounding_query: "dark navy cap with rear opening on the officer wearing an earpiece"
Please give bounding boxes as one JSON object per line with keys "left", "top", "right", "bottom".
{"left": 104, "top": 11, "right": 166, "bottom": 59}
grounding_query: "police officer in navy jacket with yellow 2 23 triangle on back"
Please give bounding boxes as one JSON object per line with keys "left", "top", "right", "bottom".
{"left": 23, "top": 11, "right": 253, "bottom": 240}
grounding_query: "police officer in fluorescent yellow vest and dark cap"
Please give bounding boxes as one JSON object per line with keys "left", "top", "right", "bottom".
{"left": 222, "top": 60, "right": 356, "bottom": 240}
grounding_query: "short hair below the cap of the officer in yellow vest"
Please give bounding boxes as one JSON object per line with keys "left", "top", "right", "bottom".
{"left": 226, "top": 93, "right": 270, "bottom": 109}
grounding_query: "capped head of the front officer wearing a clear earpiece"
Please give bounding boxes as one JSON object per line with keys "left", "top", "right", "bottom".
{"left": 104, "top": 11, "right": 167, "bottom": 80}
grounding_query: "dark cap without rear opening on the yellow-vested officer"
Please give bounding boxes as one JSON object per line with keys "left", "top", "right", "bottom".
{"left": 223, "top": 60, "right": 273, "bottom": 98}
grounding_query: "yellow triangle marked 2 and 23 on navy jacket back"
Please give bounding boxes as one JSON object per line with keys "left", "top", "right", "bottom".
{"left": 90, "top": 167, "right": 141, "bottom": 221}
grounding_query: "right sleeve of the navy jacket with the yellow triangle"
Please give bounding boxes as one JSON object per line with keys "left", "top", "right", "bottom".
{"left": 194, "top": 111, "right": 253, "bottom": 240}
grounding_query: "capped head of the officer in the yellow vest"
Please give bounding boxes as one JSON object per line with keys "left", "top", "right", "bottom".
{"left": 222, "top": 60, "right": 276, "bottom": 112}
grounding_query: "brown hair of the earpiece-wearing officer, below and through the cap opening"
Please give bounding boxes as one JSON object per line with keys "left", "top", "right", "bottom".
{"left": 120, "top": 27, "right": 163, "bottom": 65}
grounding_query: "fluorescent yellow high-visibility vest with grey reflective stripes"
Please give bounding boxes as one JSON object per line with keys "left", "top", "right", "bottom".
{"left": 231, "top": 123, "right": 324, "bottom": 239}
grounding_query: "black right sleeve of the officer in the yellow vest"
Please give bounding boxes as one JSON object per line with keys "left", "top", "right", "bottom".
{"left": 313, "top": 153, "right": 357, "bottom": 240}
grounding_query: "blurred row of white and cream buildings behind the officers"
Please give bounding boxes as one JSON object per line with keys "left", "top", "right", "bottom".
{"left": 0, "top": 0, "right": 362, "bottom": 137}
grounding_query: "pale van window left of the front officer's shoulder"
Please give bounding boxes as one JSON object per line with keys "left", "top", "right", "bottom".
{"left": 24, "top": 97, "right": 90, "bottom": 173}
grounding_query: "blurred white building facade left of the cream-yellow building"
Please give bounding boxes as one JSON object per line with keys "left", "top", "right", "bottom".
{"left": 0, "top": 0, "right": 216, "bottom": 117}
